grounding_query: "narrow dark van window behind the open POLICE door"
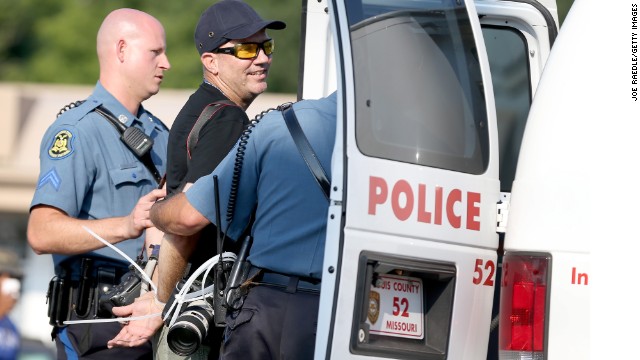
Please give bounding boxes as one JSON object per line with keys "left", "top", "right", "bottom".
{"left": 482, "top": 26, "right": 532, "bottom": 192}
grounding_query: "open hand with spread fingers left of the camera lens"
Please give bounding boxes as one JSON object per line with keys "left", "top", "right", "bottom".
{"left": 107, "top": 291, "right": 163, "bottom": 349}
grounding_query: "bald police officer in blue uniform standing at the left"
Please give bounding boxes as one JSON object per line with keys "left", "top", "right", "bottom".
{"left": 27, "top": 9, "right": 170, "bottom": 359}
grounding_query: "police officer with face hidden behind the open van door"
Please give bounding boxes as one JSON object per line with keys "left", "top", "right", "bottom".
{"left": 151, "top": 93, "right": 336, "bottom": 360}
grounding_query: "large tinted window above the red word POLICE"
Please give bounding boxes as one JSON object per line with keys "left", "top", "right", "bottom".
{"left": 347, "top": 0, "right": 489, "bottom": 174}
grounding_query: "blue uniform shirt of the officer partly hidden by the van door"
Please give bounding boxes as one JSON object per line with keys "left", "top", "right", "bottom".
{"left": 186, "top": 93, "right": 337, "bottom": 279}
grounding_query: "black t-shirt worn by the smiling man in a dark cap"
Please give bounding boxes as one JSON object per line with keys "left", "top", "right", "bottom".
{"left": 167, "top": 83, "right": 249, "bottom": 272}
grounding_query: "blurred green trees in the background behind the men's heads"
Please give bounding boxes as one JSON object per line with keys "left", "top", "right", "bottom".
{"left": 0, "top": 0, "right": 573, "bottom": 93}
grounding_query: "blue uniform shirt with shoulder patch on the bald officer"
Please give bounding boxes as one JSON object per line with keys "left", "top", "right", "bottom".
{"left": 31, "top": 81, "right": 169, "bottom": 273}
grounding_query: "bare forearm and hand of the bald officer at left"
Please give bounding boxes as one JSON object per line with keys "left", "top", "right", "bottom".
{"left": 27, "top": 189, "right": 165, "bottom": 254}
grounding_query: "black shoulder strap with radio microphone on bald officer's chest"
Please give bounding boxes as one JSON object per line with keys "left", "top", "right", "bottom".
{"left": 95, "top": 105, "right": 162, "bottom": 184}
